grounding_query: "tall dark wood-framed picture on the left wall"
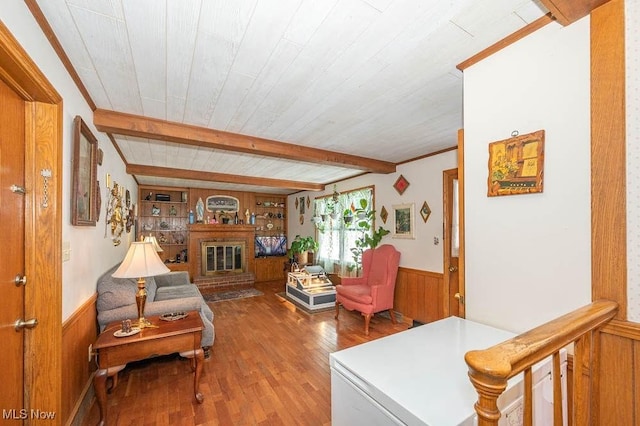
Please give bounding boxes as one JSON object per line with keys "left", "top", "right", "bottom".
{"left": 71, "top": 116, "right": 99, "bottom": 226}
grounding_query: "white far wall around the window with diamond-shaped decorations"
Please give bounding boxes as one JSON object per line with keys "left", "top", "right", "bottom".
{"left": 287, "top": 150, "right": 457, "bottom": 272}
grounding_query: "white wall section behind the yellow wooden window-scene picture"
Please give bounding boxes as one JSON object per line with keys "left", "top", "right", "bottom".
{"left": 464, "top": 17, "right": 591, "bottom": 332}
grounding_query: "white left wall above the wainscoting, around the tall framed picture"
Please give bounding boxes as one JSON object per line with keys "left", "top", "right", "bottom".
{"left": 0, "top": 0, "right": 138, "bottom": 321}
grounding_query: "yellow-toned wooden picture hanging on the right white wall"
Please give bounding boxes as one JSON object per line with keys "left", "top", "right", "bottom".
{"left": 487, "top": 130, "right": 544, "bottom": 197}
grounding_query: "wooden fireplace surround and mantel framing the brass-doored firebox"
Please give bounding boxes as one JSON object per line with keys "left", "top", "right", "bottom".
{"left": 187, "top": 223, "right": 256, "bottom": 281}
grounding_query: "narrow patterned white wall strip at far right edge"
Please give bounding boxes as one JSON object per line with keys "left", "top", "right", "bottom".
{"left": 625, "top": 1, "right": 640, "bottom": 322}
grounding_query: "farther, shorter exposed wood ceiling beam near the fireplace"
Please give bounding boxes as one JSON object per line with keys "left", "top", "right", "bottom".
{"left": 127, "top": 164, "right": 325, "bottom": 191}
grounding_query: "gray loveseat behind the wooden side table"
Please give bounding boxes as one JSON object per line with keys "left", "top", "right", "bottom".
{"left": 96, "top": 264, "right": 215, "bottom": 348}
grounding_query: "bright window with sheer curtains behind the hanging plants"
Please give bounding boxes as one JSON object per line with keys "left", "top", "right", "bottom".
{"left": 314, "top": 186, "right": 374, "bottom": 276}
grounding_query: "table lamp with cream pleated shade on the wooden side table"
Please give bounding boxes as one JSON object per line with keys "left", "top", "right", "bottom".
{"left": 111, "top": 241, "right": 169, "bottom": 328}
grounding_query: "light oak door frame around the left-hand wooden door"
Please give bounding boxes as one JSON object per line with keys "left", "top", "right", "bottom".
{"left": 0, "top": 22, "right": 63, "bottom": 421}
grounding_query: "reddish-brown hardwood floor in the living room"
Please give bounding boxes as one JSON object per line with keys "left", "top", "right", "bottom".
{"left": 82, "top": 281, "right": 407, "bottom": 426}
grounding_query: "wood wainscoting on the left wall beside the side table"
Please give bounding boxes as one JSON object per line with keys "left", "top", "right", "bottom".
{"left": 61, "top": 295, "right": 98, "bottom": 425}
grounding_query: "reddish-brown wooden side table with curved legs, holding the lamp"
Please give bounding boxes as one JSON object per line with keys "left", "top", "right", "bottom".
{"left": 93, "top": 311, "right": 204, "bottom": 425}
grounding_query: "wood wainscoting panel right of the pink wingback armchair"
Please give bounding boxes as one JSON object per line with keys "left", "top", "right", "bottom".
{"left": 393, "top": 267, "right": 444, "bottom": 324}
